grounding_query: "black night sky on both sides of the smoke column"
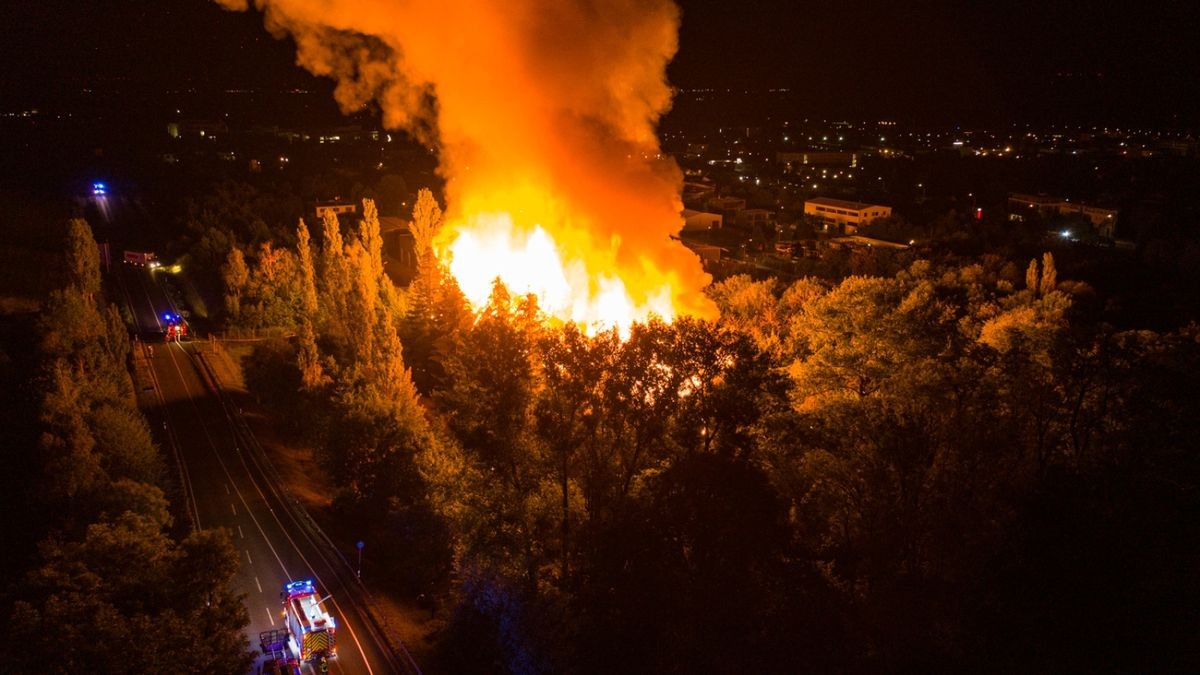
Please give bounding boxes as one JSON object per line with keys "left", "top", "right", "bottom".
{"left": 0, "top": 0, "right": 1200, "bottom": 125}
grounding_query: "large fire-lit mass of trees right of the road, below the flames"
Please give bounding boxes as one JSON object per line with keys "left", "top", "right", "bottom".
{"left": 227, "top": 193, "right": 1200, "bottom": 673}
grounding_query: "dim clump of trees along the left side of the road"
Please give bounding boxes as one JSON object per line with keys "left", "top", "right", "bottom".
{"left": 0, "top": 220, "right": 252, "bottom": 674}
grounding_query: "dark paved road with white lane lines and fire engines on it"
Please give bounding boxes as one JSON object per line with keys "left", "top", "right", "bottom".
{"left": 119, "top": 265, "right": 414, "bottom": 674}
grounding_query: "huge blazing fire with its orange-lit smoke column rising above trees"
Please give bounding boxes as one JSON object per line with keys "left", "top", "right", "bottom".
{"left": 218, "top": 0, "right": 715, "bottom": 328}
